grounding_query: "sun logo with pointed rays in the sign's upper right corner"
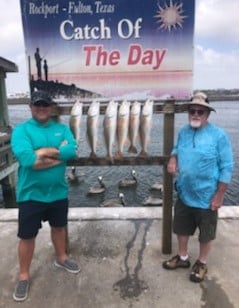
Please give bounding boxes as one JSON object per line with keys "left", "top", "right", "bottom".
{"left": 154, "top": 0, "right": 187, "bottom": 32}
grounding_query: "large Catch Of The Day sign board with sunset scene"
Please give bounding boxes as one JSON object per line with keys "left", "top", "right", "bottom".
{"left": 21, "top": 0, "right": 195, "bottom": 99}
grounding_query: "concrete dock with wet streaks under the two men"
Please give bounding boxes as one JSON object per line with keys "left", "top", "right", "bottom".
{"left": 0, "top": 206, "right": 239, "bottom": 308}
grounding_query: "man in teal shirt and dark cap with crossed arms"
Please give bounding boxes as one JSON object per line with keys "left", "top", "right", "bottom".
{"left": 11, "top": 91, "right": 80, "bottom": 301}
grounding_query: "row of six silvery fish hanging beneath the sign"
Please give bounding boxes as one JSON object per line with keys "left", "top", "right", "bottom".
{"left": 69, "top": 100, "right": 153, "bottom": 161}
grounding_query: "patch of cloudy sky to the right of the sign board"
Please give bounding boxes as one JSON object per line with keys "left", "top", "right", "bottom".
{"left": 194, "top": 0, "right": 239, "bottom": 89}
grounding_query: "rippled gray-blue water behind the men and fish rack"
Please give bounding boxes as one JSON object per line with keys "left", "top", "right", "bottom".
{"left": 0, "top": 101, "right": 239, "bottom": 207}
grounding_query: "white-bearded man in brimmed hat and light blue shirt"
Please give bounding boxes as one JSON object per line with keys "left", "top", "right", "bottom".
{"left": 163, "top": 92, "right": 233, "bottom": 282}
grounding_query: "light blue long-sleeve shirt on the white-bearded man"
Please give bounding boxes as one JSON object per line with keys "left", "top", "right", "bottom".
{"left": 171, "top": 123, "right": 233, "bottom": 208}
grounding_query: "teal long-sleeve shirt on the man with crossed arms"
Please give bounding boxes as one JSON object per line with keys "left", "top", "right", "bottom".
{"left": 11, "top": 118, "right": 77, "bottom": 202}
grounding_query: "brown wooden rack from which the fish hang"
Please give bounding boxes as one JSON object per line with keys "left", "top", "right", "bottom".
{"left": 51, "top": 99, "right": 187, "bottom": 254}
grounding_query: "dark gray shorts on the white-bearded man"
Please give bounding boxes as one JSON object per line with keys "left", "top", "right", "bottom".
{"left": 173, "top": 199, "right": 218, "bottom": 243}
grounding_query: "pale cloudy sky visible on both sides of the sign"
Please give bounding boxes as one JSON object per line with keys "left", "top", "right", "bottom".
{"left": 0, "top": 0, "right": 239, "bottom": 94}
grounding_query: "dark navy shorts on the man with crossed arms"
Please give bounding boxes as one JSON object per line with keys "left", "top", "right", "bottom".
{"left": 17, "top": 199, "right": 68, "bottom": 239}
